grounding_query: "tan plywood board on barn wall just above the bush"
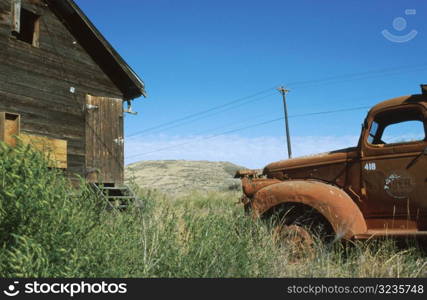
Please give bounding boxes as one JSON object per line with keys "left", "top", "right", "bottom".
{"left": 19, "top": 133, "right": 67, "bottom": 169}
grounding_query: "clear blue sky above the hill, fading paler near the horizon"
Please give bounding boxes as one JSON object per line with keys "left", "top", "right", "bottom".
{"left": 76, "top": 0, "right": 427, "bottom": 168}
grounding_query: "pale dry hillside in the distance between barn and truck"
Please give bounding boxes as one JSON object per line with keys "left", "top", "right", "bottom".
{"left": 125, "top": 160, "right": 245, "bottom": 194}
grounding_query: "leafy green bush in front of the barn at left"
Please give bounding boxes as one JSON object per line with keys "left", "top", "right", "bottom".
{"left": 0, "top": 143, "right": 100, "bottom": 277}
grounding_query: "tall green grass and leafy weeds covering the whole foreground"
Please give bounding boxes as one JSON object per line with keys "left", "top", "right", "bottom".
{"left": 0, "top": 144, "right": 427, "bottom": 278}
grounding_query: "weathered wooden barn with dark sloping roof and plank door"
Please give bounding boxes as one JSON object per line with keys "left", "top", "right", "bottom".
{"left": 0, "top": 0, "right": 145, "bottom": 197}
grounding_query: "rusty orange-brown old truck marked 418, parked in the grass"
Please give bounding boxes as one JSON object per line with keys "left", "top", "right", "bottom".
{"left": 236, "top": 85, "right": 427, "bottom": 244}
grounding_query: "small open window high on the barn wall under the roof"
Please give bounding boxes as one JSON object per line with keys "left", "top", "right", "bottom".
{"left": 13, "top": 7, "right": 40, "bottom": 47}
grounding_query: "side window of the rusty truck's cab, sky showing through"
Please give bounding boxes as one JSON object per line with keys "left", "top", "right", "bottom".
{"left": 368, "top": 108, "right": 426, "bottom": 145}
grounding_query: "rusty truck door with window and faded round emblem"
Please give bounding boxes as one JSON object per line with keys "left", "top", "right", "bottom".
{"left": 361, "top": 103, "right": 427, "bottom": 228}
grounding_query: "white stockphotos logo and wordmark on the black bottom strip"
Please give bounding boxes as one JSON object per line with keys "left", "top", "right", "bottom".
{"left": 3, "top": 281, "right": 127, "bottom": 297}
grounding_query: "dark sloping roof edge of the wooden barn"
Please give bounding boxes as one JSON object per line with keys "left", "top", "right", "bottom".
{"left": 45, "top": 0, "right": 146, "bottom": 100}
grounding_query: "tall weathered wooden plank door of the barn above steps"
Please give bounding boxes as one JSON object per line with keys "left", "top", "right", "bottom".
{"left": 85, "top": 95, "right": 124, "bottom": 184}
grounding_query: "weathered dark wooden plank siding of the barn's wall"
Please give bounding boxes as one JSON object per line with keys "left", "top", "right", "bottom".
{"left": 0, "top": 0, "right": 123, "bottom": 180}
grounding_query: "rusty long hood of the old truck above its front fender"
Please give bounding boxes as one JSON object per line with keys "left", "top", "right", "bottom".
{"left": 263, "top": 147, "right": 357, "bottom": 177}
